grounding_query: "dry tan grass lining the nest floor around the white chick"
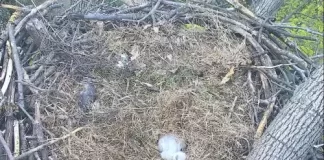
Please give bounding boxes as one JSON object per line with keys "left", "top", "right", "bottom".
{"left": 44, "top": 23, "right": 254, "bottom": 160}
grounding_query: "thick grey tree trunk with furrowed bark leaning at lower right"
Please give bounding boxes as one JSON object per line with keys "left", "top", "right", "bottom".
{"left": 248, "top": 66, "right": 324, "bottom": 160}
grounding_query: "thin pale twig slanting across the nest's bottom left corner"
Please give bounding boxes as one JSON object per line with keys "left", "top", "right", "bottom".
{"left": 15, "top": 127, "right": 84, "bottom": 160}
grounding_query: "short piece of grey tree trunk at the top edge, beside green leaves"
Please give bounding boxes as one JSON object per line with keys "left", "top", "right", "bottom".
{"left": 250, "top": 0, "right": 284, "bottom": 18}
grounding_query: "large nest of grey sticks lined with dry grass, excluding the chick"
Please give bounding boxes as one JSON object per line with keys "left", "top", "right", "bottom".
{"left": 0, "top": 0, "right": 322, "bottom": 159}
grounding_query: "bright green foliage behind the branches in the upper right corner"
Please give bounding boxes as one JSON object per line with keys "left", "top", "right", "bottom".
{"left": 277, "top": 0, "right": 323, "bottom": 56}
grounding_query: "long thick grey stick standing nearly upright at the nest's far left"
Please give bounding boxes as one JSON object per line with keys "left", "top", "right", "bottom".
{"left": 8, "top": 23, "right": 25, "bottom": 108}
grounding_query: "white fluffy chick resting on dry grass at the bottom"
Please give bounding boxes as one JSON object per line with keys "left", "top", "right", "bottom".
{"left": 158, "top": 134, "right": 186, "bottom": 160}
